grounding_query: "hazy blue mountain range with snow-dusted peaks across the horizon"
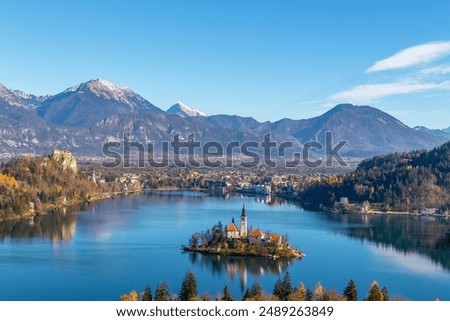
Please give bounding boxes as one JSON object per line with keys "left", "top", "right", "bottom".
{"left": 0, "top": 79, "right": 450, "bottom": 158}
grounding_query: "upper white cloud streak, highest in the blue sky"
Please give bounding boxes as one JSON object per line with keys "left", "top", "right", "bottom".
{"left": 366, "top": 41, "right": 450, "bottom": 73}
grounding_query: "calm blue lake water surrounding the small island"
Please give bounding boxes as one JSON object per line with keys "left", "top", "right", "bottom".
{"left": 0, "top": 192, "right": 450, "bottom": 300}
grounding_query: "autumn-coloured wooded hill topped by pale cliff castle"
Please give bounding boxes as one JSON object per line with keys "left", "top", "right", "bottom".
{"left": 0, "top": 150, "right": 103, "bottom": 222}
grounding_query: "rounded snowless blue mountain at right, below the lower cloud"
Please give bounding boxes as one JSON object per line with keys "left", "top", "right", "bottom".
{"left": 278, "top": 104, "right": 444, "bottom": 157}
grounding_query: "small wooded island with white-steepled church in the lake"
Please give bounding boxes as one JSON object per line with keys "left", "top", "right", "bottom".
{"left": 182, "top": 205, "right": 304, "bottom": 259}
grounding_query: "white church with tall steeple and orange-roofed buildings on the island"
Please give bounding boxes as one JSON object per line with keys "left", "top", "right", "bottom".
{"left": 225, "top": 205, "right": 282, "bottom": 246}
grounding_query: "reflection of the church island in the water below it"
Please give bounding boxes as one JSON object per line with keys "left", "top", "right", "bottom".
{"left": 186, "top": 252, "right": 293, "bottom": 291}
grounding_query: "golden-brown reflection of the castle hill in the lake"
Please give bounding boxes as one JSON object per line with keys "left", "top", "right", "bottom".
{"left": 0, "top": 210, "right": 77, "bottom": 242}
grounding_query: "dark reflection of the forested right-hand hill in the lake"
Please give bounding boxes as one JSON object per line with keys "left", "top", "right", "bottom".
{"left": 322, "top": 214, "right": 450, "bottom": 270}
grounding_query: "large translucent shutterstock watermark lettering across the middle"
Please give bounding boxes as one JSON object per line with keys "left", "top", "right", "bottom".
{"left": 102, "top": 132, "right": 348, "bottom": 168}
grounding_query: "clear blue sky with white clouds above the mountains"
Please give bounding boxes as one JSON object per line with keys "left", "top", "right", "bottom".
{"left": 0, "top": 0, "right": 450, "bottom": 128}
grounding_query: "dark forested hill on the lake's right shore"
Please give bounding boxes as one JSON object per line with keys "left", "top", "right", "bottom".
{"left": 298, "top": 142, "right": 450, "bottom": 211}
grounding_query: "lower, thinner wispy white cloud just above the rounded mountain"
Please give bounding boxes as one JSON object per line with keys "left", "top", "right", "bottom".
{"left": 330, "top": 81, "right": 450, "bottom": 104}
